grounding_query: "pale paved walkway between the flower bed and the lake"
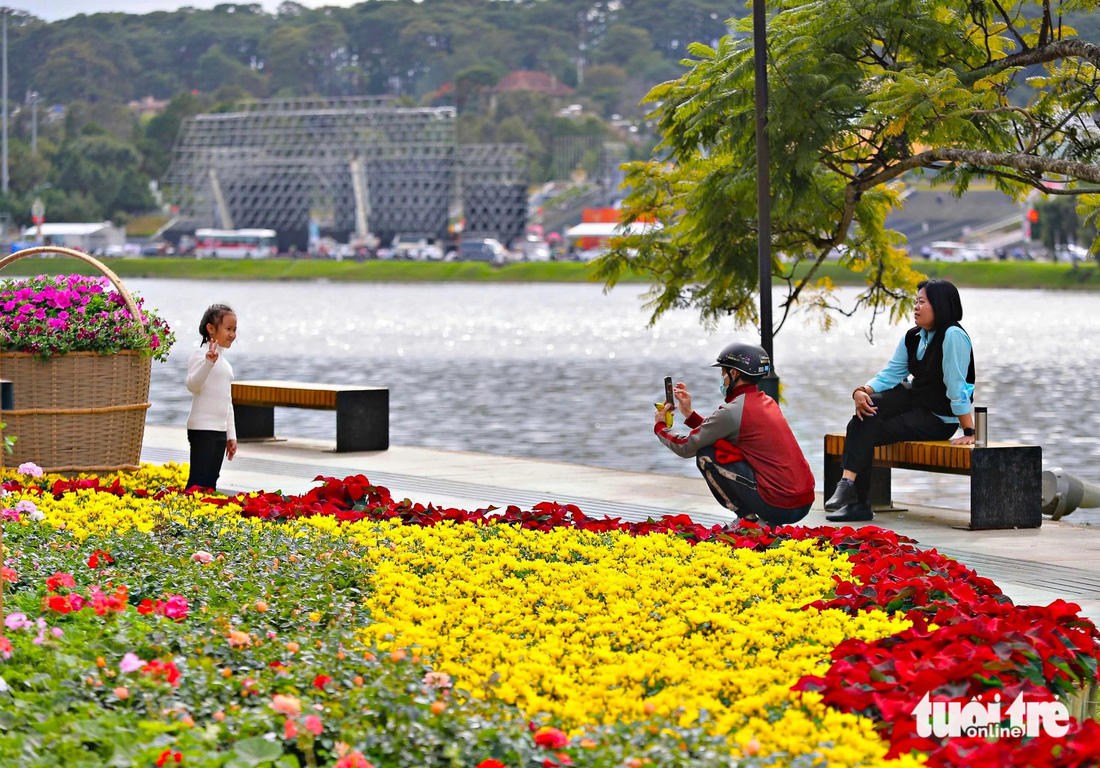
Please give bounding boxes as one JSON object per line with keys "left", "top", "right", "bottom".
{"left": 142, "top": 427, "right": 1100, "bottom": 622}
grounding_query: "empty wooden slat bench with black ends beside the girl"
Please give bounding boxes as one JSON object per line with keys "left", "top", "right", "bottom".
{"left": 233, "top": 381, "right": 389, "bottom": 453}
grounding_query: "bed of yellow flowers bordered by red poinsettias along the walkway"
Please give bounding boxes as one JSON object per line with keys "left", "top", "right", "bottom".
{"left": 0, "top": 465, "right": 1096, "bottom": 767}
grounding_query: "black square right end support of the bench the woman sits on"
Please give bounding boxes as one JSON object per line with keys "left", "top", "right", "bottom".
{"left": 970, "top": 446, "right": 1043, "bottom": 530}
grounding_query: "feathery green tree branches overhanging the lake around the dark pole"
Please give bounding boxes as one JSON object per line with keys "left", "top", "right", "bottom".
{"left": 600, "top": 0, "right": 1100, "bottom": 326}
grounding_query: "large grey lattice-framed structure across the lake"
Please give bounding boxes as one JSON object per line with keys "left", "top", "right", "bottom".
{"left": 165, "top": 97, "right": 527, "bottom": 248}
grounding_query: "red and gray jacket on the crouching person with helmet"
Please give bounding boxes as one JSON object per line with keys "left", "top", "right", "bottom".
{"left": 653, "top": 384, "right": 814, "bottom": 509}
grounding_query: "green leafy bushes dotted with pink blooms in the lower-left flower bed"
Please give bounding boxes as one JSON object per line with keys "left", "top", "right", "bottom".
{"left": 0, "top": 501, "right": 800, "bottom": 768}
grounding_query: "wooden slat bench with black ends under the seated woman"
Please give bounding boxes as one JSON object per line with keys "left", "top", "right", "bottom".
{"left": 824, "top": 434, "right": 1043, "bottom": 530}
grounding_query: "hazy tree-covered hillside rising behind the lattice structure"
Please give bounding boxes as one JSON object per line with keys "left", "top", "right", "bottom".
{"left": 0, "top": 0, "right": 1100, "bottom": 229}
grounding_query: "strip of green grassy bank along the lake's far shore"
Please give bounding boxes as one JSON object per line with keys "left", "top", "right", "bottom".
{"left": 0, "top": 253, "right": 1100, "bottom": 290}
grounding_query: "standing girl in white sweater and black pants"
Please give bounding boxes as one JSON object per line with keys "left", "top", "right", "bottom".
{"left": 187, "top": 304, "right": 237, "bottom": 491}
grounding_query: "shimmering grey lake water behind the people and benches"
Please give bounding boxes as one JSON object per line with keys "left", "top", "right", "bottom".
{"left": 128, "top": 279, "right": 1100, "bottom": 524}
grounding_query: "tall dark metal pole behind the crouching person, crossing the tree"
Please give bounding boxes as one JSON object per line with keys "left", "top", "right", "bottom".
{"left": 752, "top": 0, "right": 779, "bottom": 403}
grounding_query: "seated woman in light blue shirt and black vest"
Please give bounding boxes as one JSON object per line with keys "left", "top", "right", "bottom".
{"left": 825, "top": 279, "right": 975, "bottom": 523}
